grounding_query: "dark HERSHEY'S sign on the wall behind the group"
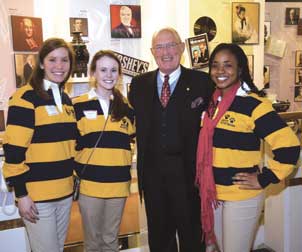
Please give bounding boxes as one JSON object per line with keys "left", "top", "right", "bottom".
{"left": 114, "top": 52, "right": 149, "bottom": 77}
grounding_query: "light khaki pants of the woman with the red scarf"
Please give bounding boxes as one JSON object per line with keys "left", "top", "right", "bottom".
{"left": 214, "top": 193, "right": 264, "bottom": 252}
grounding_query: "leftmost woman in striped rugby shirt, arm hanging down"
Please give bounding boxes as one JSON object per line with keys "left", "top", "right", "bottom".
{"left": 3, "top": 38, "right": 77, "bottom": 252}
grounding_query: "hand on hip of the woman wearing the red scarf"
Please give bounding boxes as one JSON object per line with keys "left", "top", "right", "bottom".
{"left": 233, "top": 172, "right": 262, "bottom": 190}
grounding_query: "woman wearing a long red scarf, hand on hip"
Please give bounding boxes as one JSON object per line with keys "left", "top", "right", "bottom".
{"left": 196, "top": 44, "right": 300, "bottom": 252}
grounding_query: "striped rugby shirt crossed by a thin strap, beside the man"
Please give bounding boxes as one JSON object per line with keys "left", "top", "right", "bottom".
{"left": 73, "top": 89, "right": 135, "bottom": 198}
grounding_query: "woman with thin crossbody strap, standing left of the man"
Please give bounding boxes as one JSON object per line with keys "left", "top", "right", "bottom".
{"left": 74, "top": 50, "right": 135, "bottom": 252}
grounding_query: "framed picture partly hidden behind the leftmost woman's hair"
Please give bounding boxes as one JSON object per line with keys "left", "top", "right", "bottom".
{"left": 15, "top": 53, "right": 38, "bottom": 88}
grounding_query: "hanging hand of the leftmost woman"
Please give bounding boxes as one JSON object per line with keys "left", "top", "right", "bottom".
{"left": 18, "top": 195, "right": 39, "bottom": 223}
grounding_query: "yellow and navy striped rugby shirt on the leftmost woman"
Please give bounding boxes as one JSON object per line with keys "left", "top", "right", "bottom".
{"left": 3, "top": 85, "right": 77, "bottom": 202}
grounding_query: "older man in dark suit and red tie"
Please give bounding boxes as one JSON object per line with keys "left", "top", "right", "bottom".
{"left": 129, "top": 28, "right": 213, "bottom": 252}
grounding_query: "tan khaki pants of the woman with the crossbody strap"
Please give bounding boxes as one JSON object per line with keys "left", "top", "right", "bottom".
{"left": 79, "top": 194, "right": 126, "bottom": 252}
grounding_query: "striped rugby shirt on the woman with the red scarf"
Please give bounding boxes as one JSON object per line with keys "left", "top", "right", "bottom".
{"left": 208, "top": 88, "right": 300, "bottom": 201}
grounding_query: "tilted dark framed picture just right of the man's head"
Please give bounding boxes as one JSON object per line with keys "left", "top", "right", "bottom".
{"left": 186, "top": 33, "right": 209, "bottom": 70}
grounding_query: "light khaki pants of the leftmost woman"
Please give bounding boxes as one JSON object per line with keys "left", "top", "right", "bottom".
{"left": 23, "top": 197, "right": 72, "bottom": 252}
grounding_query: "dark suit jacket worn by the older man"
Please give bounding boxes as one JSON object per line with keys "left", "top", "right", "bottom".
{"left": 129, "top": 67, "right": 214, "bottom": 198}
